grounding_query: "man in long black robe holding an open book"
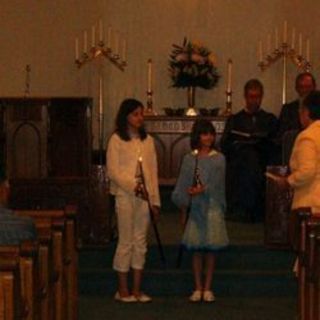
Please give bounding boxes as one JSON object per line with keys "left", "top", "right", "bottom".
{"left": 221, "top": 79, "right": 277, "bottom": 222}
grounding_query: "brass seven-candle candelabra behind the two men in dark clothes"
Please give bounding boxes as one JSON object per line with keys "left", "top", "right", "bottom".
{"left": 258, "top": 21, "right": 311, "bottom": 104}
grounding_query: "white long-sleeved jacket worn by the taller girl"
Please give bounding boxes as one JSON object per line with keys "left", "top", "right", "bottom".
{"left": 107, "top": 133, "right": 160, "bottom": 206}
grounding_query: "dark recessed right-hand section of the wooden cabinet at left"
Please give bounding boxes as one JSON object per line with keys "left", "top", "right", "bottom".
{"left": 48, "top": 98, "right": 91, "bottom": 177}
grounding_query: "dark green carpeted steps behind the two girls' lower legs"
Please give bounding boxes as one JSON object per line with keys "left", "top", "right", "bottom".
{"left": 79, "top": 244, "right": 297, "bottom": 297}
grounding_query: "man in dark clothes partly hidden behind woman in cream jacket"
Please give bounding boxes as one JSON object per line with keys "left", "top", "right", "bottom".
{"left": 277, "top": 72, "right": 316, "bottom": 164}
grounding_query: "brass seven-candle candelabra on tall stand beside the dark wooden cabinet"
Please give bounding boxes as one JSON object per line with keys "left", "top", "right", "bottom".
{"left": 75, "top": 20, "right": 127, "bottom": 164}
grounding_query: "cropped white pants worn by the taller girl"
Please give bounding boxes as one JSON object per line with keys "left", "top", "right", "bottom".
{"left": 113, "top": 194, "right": 150, "bottom": 272}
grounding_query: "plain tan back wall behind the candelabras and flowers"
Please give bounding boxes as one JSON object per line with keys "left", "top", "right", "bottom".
{"left": 0, "top": 0, "right": 320, "bottom": 146}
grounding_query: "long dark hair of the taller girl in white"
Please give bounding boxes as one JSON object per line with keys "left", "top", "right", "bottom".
{"left": 115, "top": 98, "right": 147, "bottom": 141}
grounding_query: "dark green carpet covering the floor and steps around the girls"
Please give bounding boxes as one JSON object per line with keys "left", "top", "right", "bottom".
{"left": 79, "top": 195, "right": 297, "bottom": 320}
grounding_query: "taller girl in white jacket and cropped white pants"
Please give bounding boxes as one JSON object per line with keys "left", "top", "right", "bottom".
{"left": 107, "top": 99, "right": 160, "bottom": 302}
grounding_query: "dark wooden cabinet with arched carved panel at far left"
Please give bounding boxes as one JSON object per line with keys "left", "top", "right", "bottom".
{"left": 0, "top": 98, "right": 92, "bottom": 179}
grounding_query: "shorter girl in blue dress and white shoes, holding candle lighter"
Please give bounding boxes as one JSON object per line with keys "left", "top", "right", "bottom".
{"left": 172, "top": 119, "right": 229, "bottom": 302}
